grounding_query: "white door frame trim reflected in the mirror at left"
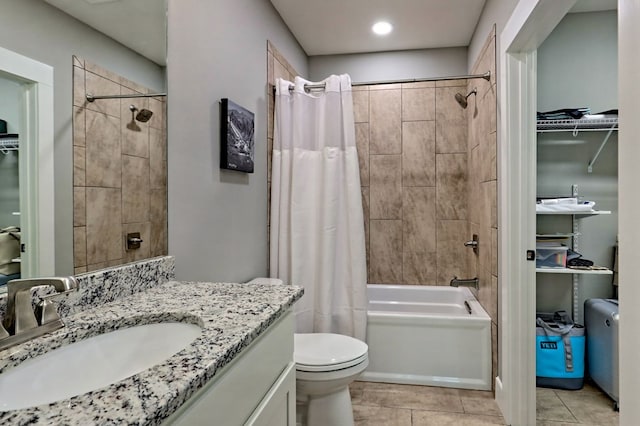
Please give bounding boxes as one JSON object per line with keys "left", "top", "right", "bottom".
{"left": 0, "top": 48, "right": 55, "bottom": 277}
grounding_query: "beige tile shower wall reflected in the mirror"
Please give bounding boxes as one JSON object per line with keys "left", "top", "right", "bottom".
{"left": 73, "top": 57, "right": 167, "bottom": 273}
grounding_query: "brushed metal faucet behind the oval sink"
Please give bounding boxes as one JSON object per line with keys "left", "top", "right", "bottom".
{"left": 0, "top": 277, "right": 78, "bottom": 350}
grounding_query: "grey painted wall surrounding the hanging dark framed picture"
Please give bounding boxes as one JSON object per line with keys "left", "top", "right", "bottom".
{"left": 167, "top": 0, "right": 307, "bottom": 282}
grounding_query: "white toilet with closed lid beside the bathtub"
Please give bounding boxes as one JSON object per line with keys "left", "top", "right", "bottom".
{"left": 249, "top": 278, "right": 369, "bottom": 426}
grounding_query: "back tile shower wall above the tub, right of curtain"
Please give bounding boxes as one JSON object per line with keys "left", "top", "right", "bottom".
{"left": 353, "top": 80, "right": 469, "bottom": 285}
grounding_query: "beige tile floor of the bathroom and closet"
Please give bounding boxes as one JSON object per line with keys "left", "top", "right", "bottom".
{"left": 350, "top": 382, "right": 618, "bottom": 426}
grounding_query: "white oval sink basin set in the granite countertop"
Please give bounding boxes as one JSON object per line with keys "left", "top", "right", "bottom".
{"left": 0, "top": 322, "right": 202, "bottom": 411}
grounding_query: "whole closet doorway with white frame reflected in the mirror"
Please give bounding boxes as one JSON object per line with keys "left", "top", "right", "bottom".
{"left": 0, "top": 48, "right": 55, "bottom": 292}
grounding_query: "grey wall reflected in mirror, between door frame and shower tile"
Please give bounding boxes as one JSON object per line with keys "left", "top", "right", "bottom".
{"left": 0, "top": 0, "right": 164, "bottom": 275}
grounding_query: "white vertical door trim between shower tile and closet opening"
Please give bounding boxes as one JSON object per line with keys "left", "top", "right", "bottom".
{"left": 496, "top": 46, "right": 536, "bottom": 425}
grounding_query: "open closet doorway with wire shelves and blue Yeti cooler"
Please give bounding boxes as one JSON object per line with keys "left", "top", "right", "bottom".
{"left": 536, "top": 5, "right": 619, "bottom": 426}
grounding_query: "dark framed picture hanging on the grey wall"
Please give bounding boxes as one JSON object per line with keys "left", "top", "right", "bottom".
{"left": 220, "top": 98, "right": 254, "bottom": 173}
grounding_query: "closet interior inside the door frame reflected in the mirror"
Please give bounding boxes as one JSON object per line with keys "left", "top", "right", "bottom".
{"left": 0, "top": 76, "right": 22, "bottom": 286}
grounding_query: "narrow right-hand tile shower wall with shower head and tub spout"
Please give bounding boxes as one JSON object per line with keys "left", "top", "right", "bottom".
{"left": 466, "top": 27, "right": 498, "bottom": 382}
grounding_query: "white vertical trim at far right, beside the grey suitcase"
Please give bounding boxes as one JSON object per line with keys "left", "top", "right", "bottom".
{"left": 618, "top": 0, "right": 640, "bottom": 426}
